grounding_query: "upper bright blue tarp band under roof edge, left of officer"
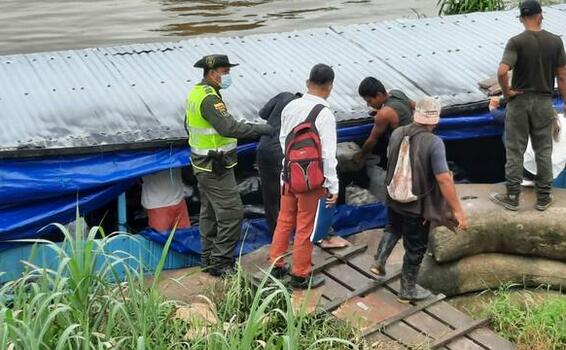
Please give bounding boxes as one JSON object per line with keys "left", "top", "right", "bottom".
{"left": 0, "top": 149, "right": 189, "bottom": 205}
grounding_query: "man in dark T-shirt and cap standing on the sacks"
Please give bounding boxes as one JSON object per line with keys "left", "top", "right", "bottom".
{"left": 489, "top": 0, "right": 566, "bottom": 211}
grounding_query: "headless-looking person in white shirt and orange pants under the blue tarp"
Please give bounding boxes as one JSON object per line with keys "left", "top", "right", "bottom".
{"left": 141, "top": 168, "right": 190, "bottom": 233}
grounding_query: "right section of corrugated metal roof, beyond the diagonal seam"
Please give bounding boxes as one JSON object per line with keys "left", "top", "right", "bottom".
{"left": 335, "top": 8, "right": 566, "bottom": 105}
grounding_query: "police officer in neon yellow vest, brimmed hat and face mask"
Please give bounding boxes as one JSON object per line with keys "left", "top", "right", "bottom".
{"left": 186, "top": 55, "right": 273, "bottom": 276}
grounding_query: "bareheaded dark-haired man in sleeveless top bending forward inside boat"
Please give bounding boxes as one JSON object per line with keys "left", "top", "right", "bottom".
{"left": 355, "top": 77, "right": 415, "bottom": 168}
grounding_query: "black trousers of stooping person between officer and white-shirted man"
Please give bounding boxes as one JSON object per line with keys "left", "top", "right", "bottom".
{"left": 257, "top": 152, "right": 283, "bottom": 236}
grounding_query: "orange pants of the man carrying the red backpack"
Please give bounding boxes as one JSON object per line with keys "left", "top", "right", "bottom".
{"left": 269, "top": 189, "right": 324, "bottom": 277}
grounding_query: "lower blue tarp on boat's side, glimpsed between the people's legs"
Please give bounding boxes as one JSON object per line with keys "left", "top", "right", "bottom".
{"left": 141, "top": 203, "right": 387, "bottom": 256}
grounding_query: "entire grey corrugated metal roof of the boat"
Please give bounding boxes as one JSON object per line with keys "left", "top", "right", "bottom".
{"left": 0, "top": 6, "right": 566, "bottom": 154}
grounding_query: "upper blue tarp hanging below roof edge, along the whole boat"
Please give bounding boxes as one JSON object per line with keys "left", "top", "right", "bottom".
{"left": 0, "top": 100, "right": 558, "bottom": 245}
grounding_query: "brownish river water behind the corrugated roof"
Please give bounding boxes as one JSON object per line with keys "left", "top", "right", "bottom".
{"left": 0, "top": 0, "right": 437, "bottom": 55}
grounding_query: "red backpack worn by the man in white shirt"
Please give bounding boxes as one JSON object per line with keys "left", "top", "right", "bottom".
{"left": 283, "top": 104, "right": 324, "bottom": 193}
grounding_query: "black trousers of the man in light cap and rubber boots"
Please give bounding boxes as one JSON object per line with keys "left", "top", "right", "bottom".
{"left": 389, "top": 210, "right": 430, "bottom": 265}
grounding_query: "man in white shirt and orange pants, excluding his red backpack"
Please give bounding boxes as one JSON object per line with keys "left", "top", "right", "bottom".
{"left": 270, "top": 64, "right": 338, "bottom": 289}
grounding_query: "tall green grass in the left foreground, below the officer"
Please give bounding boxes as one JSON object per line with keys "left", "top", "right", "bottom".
{"left": 0, "top": 220, "right": 359, "bottom": 350}
